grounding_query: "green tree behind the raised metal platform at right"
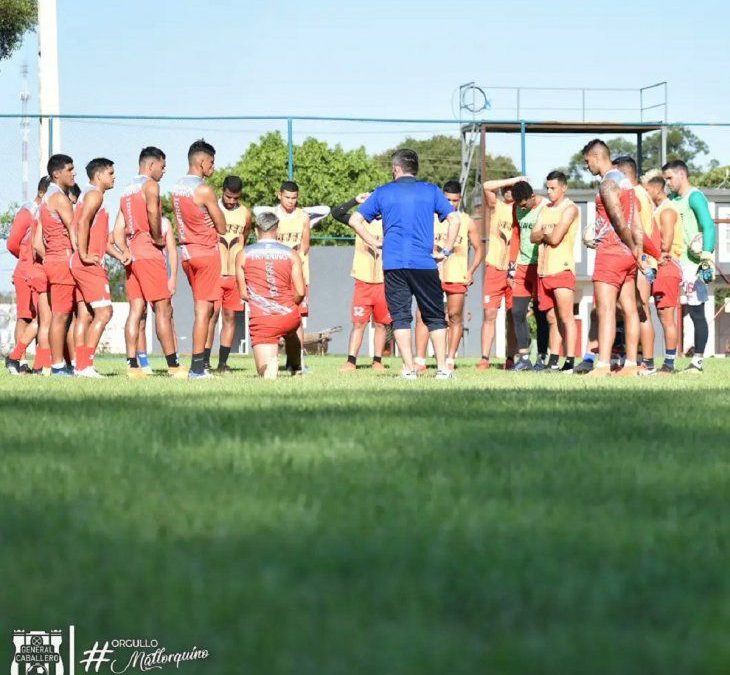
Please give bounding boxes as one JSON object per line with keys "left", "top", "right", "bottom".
{"left": 567, "top": 127, "right": 713, "bottom": 187}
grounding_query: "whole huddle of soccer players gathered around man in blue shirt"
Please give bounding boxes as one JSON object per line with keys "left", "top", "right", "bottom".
{"left": 6, "top": 140, "right": 715, "bottom": 379}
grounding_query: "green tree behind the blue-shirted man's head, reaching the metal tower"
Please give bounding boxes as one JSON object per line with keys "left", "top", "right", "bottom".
{"left": 376, "top": 135, "right": 519, "bottom": 193}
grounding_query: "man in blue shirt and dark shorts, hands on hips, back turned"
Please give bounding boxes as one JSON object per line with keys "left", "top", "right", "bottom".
{"left": 350, "top": 149, "right": 459, "bottom": 379}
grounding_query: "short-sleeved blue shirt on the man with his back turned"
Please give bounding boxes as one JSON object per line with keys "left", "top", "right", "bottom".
{"left": 358, "top": 176, "right": 454, "bottom": 270}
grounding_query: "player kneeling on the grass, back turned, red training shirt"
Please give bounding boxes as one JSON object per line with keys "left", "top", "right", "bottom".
{"left": 235, "top": 211, "right": 306, "bottom": 379}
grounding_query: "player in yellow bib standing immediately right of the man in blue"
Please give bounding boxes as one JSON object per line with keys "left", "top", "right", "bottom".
{"left": 414, "top": 180, "right": 484, "bottom": 372}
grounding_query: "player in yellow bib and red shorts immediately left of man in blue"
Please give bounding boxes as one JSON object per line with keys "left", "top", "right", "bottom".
{"left": 332, "top": 192, "right": 392, "bottom": 372}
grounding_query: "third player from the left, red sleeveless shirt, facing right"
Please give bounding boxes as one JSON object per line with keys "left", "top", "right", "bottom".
{"left": 70, "top": 157, "right": 122, "bottom": 378}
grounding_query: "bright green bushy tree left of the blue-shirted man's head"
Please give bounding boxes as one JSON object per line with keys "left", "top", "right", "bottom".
{"left": 200, "top": 131, "right": 390, "bottom": 236}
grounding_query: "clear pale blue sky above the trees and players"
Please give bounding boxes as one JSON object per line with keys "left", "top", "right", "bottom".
{"left": 0, "top": 0, "right": 730, "bottom": 291}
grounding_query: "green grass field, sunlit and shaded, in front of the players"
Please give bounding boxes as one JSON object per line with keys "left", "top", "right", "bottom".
{"left": 0, "top": 358, "right": 730, "bottom": 675}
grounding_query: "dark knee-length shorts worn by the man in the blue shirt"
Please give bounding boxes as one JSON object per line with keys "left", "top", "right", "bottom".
{"left": 383, "top": 269, "right": 446, "bottom": 330}
